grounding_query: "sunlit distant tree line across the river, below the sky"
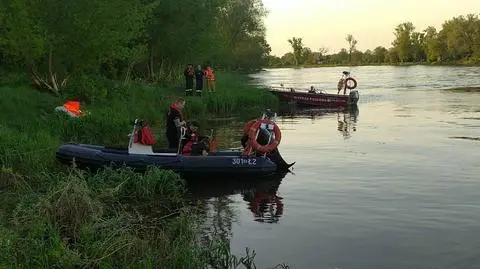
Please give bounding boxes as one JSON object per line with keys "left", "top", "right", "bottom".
{"left": 269, "top": 14, "right": 480, "bottom": 67}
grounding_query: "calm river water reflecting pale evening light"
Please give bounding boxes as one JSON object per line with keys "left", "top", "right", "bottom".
{"left": 188, "top": 66, "right": 480, "bottom": 269}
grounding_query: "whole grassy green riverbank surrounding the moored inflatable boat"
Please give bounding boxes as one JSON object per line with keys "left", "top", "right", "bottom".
{"left": 0, "top": 73, "right": 284, "bottom": 268}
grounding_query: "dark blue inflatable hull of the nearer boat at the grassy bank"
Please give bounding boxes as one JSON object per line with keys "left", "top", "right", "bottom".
{"left": 56, "top": 144, "right": 288, "bottom": 178}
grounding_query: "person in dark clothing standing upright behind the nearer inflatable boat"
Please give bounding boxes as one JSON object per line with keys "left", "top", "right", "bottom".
{"left": 166, "top": 97, "right": 185, "bottom": 150}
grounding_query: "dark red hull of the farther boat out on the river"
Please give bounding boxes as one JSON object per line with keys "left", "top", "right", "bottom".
{"left": 269, "top": 90, "right": 359, "bottom": 107}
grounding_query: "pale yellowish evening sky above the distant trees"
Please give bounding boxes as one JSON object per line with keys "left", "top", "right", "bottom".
{"left": 263, "top": 0, "right": 480, "bottom": 56}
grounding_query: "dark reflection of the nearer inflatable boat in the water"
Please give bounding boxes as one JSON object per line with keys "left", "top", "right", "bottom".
{"left": 187, "top": 179, "right": 283, "bottom": 223}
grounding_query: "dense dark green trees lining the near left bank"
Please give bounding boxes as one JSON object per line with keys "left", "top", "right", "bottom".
{"left": 0, "top": 0, "right": 270, "bottom": 92}
